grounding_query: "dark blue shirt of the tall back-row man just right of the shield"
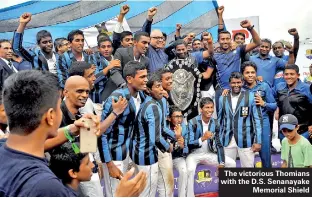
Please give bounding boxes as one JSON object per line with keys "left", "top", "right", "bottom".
{"left": 213, "top": 45, "right": 246, "bottom": 89}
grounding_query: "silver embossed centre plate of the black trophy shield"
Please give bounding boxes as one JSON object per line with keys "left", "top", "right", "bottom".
{"left": 170, "top": 69, "right": 196, "bottom": 111}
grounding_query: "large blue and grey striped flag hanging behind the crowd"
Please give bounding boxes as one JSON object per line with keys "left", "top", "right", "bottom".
{"left": 0, "top": 0, "right": 218, "bottom": 47}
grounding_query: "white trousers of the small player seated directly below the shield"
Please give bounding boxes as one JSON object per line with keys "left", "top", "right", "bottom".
{"left": 173, "top": 157, "right": 187, "bottom": 197}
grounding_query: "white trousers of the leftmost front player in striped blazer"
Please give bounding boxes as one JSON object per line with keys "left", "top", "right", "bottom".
{"left": 103, "top": 156, "right": 129, "bottom": 197}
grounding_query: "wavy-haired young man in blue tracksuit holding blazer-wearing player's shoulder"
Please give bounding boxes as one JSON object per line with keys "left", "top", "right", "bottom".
{"left": 242, "top": 61, "right": 277, "bottom": 168}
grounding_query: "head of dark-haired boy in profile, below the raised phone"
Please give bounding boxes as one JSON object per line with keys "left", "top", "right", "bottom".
{"left": 50, "top": 144, "right": 94, "bottom": 197}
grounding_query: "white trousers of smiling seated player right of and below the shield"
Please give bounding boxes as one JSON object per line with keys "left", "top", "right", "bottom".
{"left": 186, "top": 141, "right": 236, "bottom": 197}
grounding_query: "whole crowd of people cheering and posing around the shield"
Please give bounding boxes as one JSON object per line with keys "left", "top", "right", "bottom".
{"left": 0, "top": 5, "right": 312, "bottom": 197}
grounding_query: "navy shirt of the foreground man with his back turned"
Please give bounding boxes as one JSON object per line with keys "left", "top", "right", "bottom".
{"left": 0, "top": 145, "right": 78, "bottom": 197}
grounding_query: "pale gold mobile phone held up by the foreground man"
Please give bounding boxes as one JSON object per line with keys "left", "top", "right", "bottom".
{"left": 80, "top": 119, "right": 97, "bottom": 153}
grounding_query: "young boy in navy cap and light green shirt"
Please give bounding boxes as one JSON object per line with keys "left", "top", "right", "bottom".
{"left": 279, "top": 114, "right": 312, "bottom": 168}
